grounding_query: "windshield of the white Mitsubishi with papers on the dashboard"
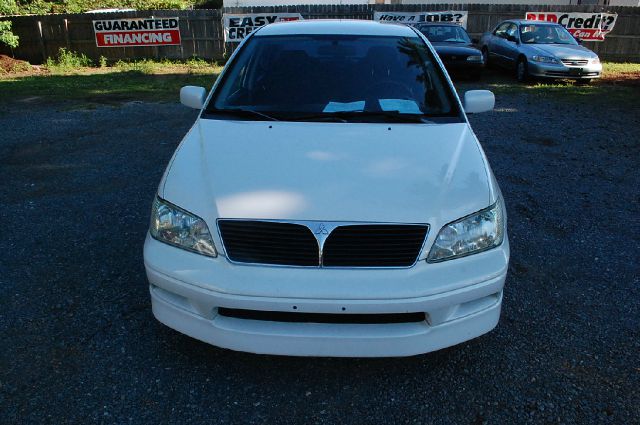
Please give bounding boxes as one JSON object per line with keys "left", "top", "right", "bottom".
{"left": 205, "top": 35, "right": 460, "bottom": 122}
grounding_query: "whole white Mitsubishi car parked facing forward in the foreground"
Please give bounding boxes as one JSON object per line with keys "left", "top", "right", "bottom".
{"left": 144, "top": 20, "right": 509, "bottom": 357}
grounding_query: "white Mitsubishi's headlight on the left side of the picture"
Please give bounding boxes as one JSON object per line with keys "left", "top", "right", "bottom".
{"left": 149, "top": 197, "right": 218, "bottom": 257}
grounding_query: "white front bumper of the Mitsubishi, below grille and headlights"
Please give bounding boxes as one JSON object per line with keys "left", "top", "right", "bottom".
{"left": 144, "top": 237, "right": 509, "bottom": 357}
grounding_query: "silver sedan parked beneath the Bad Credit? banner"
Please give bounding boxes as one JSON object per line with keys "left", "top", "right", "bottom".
{"left": 480, "top": 20, "right": 602, "bottom": 83}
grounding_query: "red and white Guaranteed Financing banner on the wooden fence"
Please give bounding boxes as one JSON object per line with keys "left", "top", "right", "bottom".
{"left": 93, "top": 18, "right": 180, "bottom": 47}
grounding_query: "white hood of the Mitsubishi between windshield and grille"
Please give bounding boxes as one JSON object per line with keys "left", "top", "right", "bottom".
{"left": 160, "top": 119, "right": 493, "bottom": 225}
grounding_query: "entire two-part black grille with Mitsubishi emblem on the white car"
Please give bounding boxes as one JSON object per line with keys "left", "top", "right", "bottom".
{"left": 218, "top": 220, "right": 429, "bottom": 267}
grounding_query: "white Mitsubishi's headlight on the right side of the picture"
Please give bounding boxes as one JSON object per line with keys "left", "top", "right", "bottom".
{"left": 427, "top": 200, "right": 504, "bottom": 263}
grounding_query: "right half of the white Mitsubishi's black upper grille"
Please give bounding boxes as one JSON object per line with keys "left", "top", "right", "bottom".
{"left": 322, "top": 225, "right": 427, "bottom": 267}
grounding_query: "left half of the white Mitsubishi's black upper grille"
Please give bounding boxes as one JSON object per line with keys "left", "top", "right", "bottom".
{"left": 218, "top": 220, "right": 319, "bottom": 267}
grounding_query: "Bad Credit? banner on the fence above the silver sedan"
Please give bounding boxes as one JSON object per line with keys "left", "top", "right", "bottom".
{"left": 525, "top": 12, "right": 618, "bottom": 41}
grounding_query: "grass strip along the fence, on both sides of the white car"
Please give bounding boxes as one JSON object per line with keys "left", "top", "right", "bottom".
{"left": 0, "top": 49, "right": 640, "bottom": 103}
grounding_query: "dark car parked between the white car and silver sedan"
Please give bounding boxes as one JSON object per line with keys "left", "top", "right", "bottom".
{"left": 416, "top": 23, "right": 484, "bottom": 79}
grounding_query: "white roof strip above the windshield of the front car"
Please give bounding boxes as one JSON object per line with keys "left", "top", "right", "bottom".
{"left": 255, "top": 19, "right": 416, "bottom": 37}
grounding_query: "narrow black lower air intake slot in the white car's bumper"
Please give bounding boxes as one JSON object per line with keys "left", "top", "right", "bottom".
{"left": 218, "top": 307, "right": 426, "bottom": 324}
